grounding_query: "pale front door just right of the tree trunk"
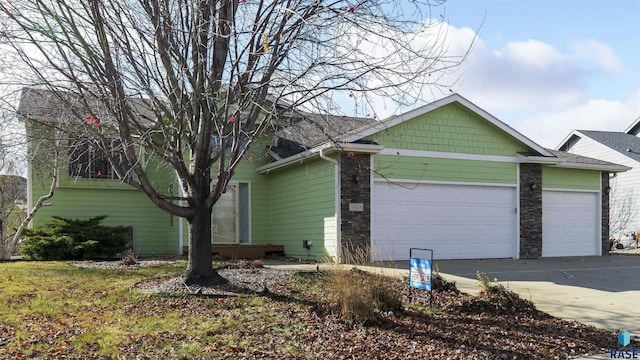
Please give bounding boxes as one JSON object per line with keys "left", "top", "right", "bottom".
{"left": 211, "top": 184, "right": 238, "bottom": 244}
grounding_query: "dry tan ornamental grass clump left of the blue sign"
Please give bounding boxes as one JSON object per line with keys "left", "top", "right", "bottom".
{"left": 327, "top": 268, "right": 402, "bottom": 324}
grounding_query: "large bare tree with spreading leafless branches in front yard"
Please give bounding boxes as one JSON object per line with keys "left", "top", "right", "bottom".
{"left": 0, "top": 0, "right": 466, "bottom": 283}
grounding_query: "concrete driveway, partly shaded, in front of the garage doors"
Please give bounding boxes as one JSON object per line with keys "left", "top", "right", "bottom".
{"left": 428, "top": 255, "right": 640, "bottom": 336}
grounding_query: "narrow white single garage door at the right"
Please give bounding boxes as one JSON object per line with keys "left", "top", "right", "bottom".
{"left": 542, "top": 191, "right": 600, "bottom": 257}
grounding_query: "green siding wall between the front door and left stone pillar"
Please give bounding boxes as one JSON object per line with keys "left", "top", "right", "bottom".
{"left": 267, "top": 160, "right": 337, "bottom": 260}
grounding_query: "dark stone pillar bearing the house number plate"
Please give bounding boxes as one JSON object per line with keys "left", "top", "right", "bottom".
{"left": 340, "top": 152, "right": 371, "bottom": 263}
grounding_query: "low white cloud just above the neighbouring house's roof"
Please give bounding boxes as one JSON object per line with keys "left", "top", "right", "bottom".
{"left": 514, "top": 90, "right": 640, "bottom": 148}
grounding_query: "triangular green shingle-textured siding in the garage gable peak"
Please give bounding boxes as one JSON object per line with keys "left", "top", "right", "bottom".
{"left": 365, "top": 103, "right": 530, "bottom": 156}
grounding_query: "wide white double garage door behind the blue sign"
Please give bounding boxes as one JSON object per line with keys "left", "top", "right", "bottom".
{"left": 371, "top": 182, "right": 516, "bottom": 260}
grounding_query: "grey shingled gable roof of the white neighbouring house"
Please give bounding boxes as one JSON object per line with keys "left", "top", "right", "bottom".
{"left": 557, "top": 130, "right": 640, "bottom": 162}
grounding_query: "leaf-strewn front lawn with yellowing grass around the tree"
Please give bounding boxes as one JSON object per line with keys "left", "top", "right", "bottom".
{"left": 0, "top": 261, "right": 637, "bottom": 359}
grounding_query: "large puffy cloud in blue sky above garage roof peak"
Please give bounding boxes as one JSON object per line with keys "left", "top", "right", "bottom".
{"left": 436, "top": 26, "right": 622, "bottom": 113}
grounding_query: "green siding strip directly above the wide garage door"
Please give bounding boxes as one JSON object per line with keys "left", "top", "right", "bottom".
{"left": 373, "top": 155, "right": 518, "bottom": 184}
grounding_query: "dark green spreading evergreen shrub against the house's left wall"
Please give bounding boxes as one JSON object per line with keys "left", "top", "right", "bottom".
{"left": 21, "top": 216, "right": 130, "bottom": 260}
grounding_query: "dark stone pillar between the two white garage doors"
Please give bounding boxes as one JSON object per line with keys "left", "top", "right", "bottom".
{"left": 520, "top": 164, "right": 542, "bottom": 259}
